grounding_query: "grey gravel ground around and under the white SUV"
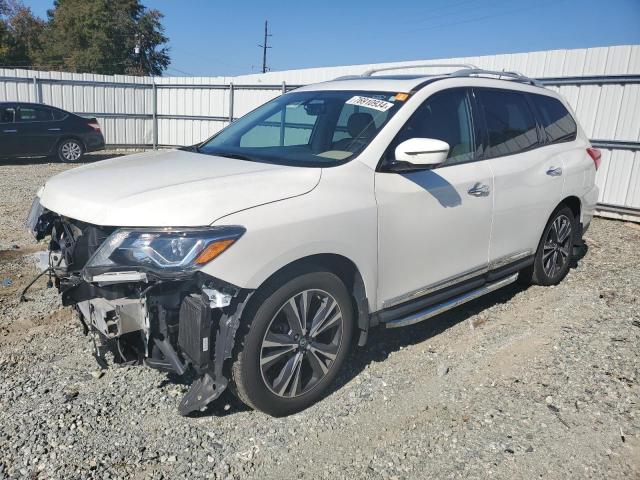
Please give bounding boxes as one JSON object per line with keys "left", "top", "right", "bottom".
{"left": 0, "top": 156, "right": 640, "bottom": 479}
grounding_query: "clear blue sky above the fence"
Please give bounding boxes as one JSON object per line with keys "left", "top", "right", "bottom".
{"left": 23, "top": 0, "right": 640, "bottom": 76}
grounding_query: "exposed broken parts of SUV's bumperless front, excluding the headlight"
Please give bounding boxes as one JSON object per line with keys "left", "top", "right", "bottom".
{"left": 27, "top": 199, "right": 252, "bottom": 415}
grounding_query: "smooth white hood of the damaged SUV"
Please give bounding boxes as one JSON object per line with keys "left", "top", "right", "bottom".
{"left": 40, "top": 150, "right": 321, "bottom": 227}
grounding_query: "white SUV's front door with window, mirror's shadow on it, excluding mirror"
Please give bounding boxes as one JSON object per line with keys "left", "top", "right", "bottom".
{"left": 375, "top": 88, "right": 493, "bottom": 308}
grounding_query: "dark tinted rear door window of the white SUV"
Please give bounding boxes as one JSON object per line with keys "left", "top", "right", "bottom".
{"left": 475, "top": 89, "right": 539, "bottom": 158}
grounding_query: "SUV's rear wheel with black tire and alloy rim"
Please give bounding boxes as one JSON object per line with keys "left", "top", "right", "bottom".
{"left": 521, "top": 206, "right": 576, "bottom": 286}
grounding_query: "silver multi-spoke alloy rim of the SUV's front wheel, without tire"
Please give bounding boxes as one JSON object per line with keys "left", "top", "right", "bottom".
{"left": 260, "top": 290, "right": 343, "bottom": 398}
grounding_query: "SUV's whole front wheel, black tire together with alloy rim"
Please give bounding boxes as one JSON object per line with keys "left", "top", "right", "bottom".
{"left": 231, "top": 269, "right": 354, "bottom": 416}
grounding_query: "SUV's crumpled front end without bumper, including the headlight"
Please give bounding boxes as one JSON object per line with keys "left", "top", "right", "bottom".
{"left": 27, "top": 199, "right": 251, "bottom": 415}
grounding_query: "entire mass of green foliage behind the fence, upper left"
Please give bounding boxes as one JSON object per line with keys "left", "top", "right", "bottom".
{"left": 0, "top": 0, "right": 170, "bottom": 75}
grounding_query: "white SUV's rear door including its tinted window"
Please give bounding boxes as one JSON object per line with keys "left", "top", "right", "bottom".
{"left": 474, "top": 88, "right": 563, "bottom": 268}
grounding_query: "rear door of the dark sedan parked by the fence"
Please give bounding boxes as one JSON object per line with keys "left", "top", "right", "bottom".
{"left": 17, "top": 105, "right": 60, "bottom": 155}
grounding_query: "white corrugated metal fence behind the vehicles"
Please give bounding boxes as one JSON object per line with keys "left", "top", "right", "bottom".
{"left": 0, "top": 45, "right": 640, "bottom": 216}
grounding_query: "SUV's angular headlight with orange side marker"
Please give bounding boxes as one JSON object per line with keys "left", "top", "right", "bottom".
{"left": 85, "top": 226, "right": 245, "bottom": 277}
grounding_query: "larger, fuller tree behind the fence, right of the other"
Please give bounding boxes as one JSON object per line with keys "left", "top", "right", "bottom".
{"left": 36, "top": 0, "right": 170, "bottom": 75}
